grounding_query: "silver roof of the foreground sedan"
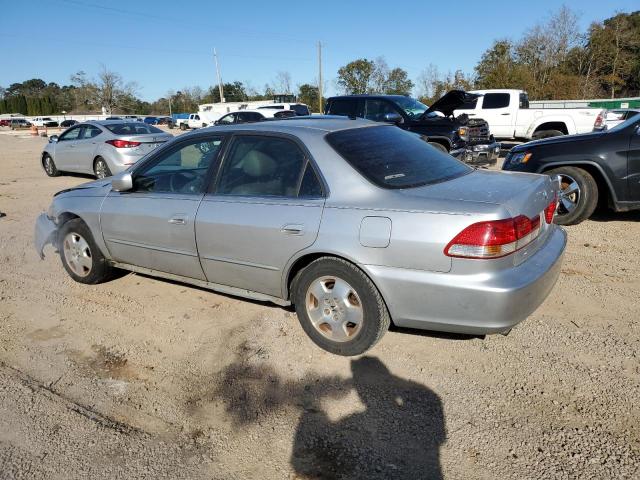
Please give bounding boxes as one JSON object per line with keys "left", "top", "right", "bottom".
{"left": 193, "top": 115, "right": 376, "bottom": 134}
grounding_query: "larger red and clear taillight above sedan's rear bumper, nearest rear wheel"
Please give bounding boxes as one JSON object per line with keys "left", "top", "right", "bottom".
{"left": 444, "top": 215, "right": 540, "bottom": 258}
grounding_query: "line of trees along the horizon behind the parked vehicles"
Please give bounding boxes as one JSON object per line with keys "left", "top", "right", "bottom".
{"left": 0, "top": 7, "right": 640, "bottom": 115}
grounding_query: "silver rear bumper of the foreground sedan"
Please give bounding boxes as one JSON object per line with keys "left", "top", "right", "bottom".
{"left": 364, "top": 227, "right": 567, "bottom": 335}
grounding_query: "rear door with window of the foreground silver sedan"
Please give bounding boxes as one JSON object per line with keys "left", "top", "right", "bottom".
{"left": 196, "top": 133, "right": 324, "bottom": 297}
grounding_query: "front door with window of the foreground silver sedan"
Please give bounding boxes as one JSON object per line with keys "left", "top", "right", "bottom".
{"left": 100, "top": 134, "right": 224, "bottom": 280}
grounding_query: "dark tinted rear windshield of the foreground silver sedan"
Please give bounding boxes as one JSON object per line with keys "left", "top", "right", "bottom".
{"left": 326, "top": 125, "right": 473, "bottom": 188}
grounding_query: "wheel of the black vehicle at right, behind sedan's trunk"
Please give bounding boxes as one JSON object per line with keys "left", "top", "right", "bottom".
{"left": 545, "top": 167, "right": 599, "bottom": 225}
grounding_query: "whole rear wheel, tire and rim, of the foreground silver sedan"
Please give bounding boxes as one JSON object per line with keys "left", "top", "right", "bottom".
{"left": 292, "top": 257, "right": 390, "bottom": 356}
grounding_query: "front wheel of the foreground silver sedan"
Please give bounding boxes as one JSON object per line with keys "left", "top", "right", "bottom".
{"left": 58, "top": 218, "right": 114, "bottom": 285}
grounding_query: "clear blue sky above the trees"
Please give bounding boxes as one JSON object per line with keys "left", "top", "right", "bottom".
{"left": 0, "top": 0, "right": 640, "bottom": 100}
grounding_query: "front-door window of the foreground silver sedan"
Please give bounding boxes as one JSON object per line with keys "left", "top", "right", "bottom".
{"left": 133, "top": 136, "right": 222, "bottom": 194}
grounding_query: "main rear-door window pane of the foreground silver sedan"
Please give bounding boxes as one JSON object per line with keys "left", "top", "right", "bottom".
{"left": 217, "top": 135, "right": 306, "bottom": 197}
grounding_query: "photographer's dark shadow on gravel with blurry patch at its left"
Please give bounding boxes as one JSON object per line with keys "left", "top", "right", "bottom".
{"left": 213, "top": 348, "right": 446, "bottom": 479}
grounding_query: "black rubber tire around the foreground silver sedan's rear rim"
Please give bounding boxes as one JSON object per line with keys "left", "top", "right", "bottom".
{"left": 292, "top": 257, "right": 391, "bottom": 356}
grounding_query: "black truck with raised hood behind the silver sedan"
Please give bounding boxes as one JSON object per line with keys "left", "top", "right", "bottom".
{"left": 324, "top": 90, "right": 500, "bottom": 165}
